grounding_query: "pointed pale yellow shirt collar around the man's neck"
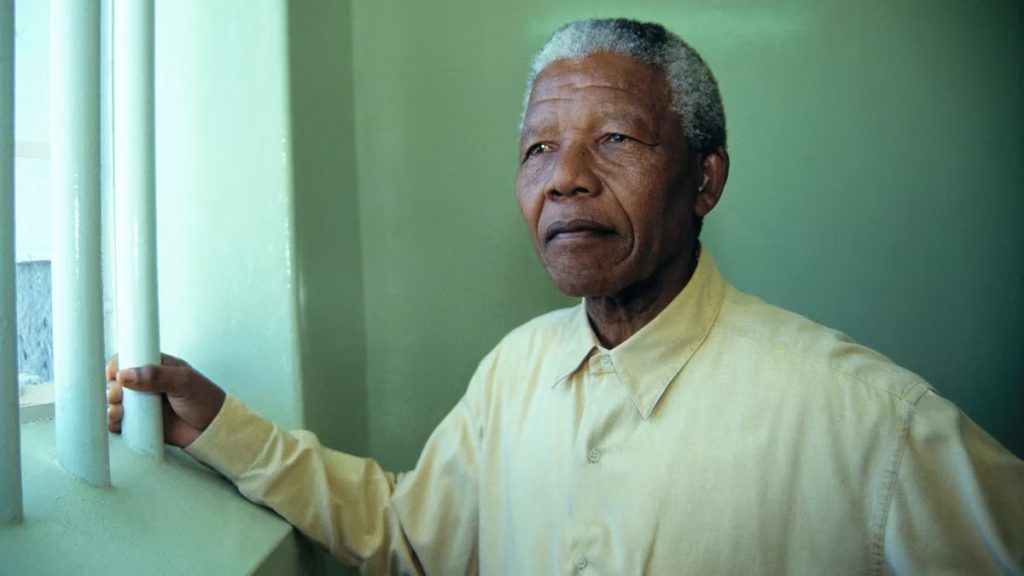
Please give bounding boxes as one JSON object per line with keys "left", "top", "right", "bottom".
{"left": 552, "top": 249, "right": 725, "bottom": 418}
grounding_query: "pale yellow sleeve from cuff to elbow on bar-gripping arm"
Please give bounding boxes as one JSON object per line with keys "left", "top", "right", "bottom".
{"left": 185, "top": 396, "right": 422, "bottom": 574}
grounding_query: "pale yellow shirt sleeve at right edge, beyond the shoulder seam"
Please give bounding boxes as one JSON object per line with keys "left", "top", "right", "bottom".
{"left": 884, "top": 392, "right": 1024, "bottom": 574}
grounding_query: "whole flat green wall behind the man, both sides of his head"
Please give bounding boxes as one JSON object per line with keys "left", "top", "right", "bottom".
{"left": 352, "top": 0, "right": 1024, "bottom": 468}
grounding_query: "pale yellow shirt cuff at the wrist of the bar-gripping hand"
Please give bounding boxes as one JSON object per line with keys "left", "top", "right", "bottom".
{"left": 184, "top": 395, "right": 276, "bottom": 482}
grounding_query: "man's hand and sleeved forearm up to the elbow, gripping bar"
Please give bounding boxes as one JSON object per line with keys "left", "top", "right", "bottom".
{"left": 106, "top": 355, "right": 421, "bottom": 574}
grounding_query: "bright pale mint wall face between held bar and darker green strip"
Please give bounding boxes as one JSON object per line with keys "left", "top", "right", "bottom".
{"left": 156, "top": 0, "right": 303, "bottom": 427}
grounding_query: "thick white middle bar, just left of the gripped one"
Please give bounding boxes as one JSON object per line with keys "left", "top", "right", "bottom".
{"left": 50, "top": 0, "right": 111, "bottom": 486}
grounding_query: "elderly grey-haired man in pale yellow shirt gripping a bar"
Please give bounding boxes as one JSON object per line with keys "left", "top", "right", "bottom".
{"left": 109, "top": 19, "right": 1024, "bottom": 575}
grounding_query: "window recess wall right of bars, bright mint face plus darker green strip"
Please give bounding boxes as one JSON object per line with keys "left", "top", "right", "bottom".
{"left": 157, "top": 0, "right": 368, "bottom": 453}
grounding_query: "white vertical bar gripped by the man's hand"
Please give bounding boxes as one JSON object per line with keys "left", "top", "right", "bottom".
{"left": 113, "top": 0, "right": 164, "bottom": 458}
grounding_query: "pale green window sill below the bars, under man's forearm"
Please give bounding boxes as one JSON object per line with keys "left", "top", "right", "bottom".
{"left": 0, "top": 414, "right": 307, "bottom": 575}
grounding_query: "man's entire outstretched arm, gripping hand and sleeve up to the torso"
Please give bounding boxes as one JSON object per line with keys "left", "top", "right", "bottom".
{"left": 108, "top": 357, "right": 479, "bottom": 574}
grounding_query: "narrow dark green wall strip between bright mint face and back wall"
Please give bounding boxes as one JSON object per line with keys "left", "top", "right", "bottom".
{"left": 288, "top": 0, "right": 368, "bottom": 454}
